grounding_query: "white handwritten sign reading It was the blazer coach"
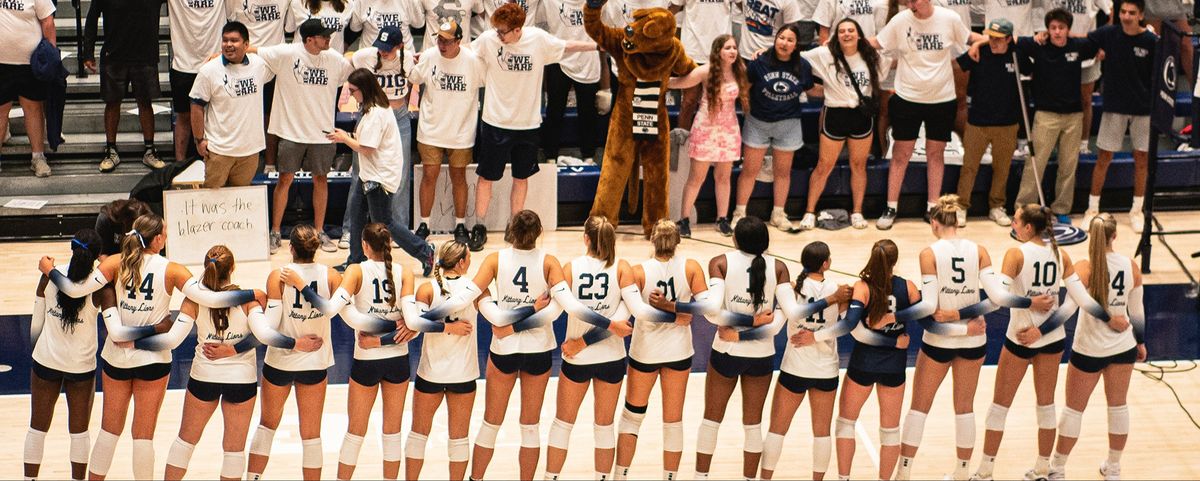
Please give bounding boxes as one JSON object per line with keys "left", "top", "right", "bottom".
{"left": 162, "top": 186, "right": 270, "bottom": 265}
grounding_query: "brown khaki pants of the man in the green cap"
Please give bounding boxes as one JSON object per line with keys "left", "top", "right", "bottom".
{"left": 959, "top": 124, "right": 1019, "bottom": 209}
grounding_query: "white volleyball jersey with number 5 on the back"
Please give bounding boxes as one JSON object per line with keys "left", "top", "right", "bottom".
{"left": 920, "top": 239, "right": 988, "bottom": 349}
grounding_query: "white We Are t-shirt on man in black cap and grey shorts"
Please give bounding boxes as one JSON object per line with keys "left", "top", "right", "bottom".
{"left": 258, "top": 43, "right": 352, "bottom": 144}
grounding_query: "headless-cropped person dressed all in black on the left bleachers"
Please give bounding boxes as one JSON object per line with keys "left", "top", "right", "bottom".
{"left": 80, "top": 0, "right": 163, "bottom": 173}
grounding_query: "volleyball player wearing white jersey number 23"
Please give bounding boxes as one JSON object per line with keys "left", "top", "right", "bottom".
{"left": 546, "top": 216, "right": 634, "bottom": 480}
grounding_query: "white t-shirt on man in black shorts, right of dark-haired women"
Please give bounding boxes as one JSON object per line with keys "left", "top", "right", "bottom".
{"left": 876, "top": 6, "right": 971, "bottom": 103}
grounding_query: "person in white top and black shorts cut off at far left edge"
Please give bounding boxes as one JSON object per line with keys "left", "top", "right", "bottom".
{"left": 0, "top": 0, "right": 58, "bottom": 178}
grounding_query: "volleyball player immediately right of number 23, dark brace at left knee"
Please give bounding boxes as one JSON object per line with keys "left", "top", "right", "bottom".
{"left": 613, "top": 220, "right": 708, "bottom": 480}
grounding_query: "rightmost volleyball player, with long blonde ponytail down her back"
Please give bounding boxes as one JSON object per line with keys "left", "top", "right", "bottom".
{"left": 1048, "top": 214, "right": 1146, "bottom": 480}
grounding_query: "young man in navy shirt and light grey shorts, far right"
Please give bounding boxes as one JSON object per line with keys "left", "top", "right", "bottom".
{"left": 1084, "top": 0, "right": 1158, "bottom": 234}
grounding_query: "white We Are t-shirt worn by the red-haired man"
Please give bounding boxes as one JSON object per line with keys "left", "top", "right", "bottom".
{"left": 474, "top": 26, "right": 566, "bottom": 131}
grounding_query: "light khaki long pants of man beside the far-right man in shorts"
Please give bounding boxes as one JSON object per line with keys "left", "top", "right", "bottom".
{"left": 1016, "top": 112, "right": 1084, "bottom": 215}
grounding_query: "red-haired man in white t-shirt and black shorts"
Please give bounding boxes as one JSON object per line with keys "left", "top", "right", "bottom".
{"left": 469, "top": 4, "right": 596, "bottom": 252}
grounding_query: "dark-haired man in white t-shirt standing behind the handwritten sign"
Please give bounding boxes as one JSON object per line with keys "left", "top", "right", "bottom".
{"left": 188, "top": 22, "right": 275, "bottom": 188}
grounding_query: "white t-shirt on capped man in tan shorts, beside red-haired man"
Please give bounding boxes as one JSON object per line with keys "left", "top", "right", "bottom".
{"left": 409, "top": 47, "right": 485, "bottom": 149}
